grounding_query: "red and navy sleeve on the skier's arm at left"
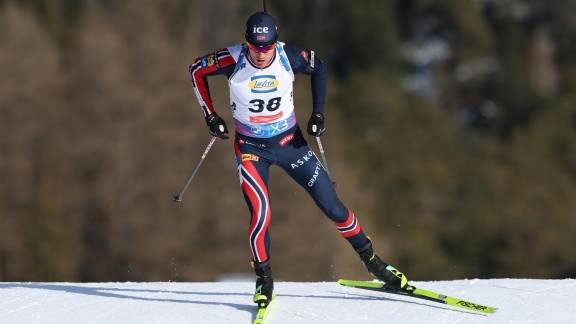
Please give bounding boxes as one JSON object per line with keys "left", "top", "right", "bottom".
{"left": 188, "top": 48, "right": 236, "bottom": 117}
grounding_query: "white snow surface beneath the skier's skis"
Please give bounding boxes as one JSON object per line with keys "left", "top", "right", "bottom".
{"left": 0, "top": 278, "right": 576, "bottom": 324}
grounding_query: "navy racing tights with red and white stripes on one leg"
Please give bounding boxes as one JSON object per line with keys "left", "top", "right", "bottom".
{"left": 234, "top": 124, "right": 367, "bottom": 262}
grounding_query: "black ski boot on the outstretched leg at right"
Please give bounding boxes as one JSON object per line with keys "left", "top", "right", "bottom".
{"left": 355, "top": 239, "right": 410, "bottom": 290}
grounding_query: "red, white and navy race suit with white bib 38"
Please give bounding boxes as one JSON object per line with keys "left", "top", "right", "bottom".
{"left": 190, "top": 42, "right": 367, "bottom": 262}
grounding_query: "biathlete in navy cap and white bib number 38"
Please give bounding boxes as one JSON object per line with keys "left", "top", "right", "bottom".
{"left": 190, "top": 12, "right": 409, "bottom": 307}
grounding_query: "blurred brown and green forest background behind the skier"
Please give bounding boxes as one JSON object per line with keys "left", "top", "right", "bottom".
{"left": 0, "top": 0, "right": 576, "bottom": 281}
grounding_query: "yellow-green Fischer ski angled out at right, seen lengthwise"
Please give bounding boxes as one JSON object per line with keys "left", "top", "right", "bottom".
{"left": 338, "top": 279, "right": 498, "bottom": 314}
